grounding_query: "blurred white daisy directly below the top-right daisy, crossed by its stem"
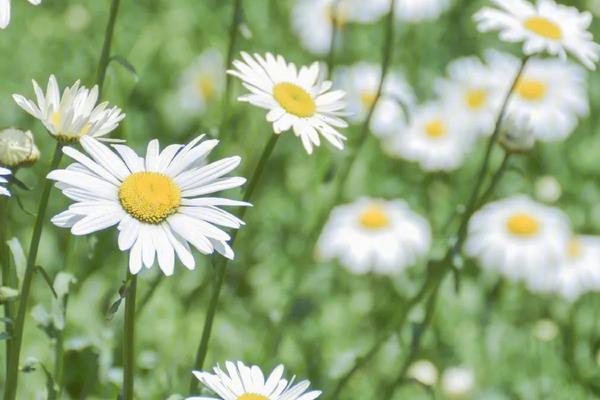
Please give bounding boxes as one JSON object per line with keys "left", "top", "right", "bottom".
{"left": 489, "top": 53, "right": 589, "bottom": 141}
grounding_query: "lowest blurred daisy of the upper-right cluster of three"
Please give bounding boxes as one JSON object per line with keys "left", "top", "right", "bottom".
{"left": 384, "top": 103, "right": 474, "bottom": 171}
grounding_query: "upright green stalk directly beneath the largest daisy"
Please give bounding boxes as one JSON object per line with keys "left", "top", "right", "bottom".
{"left": 122, "top": 271, "right": 137, "bottom": 400}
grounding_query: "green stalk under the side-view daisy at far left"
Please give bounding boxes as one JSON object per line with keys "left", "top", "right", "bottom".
{"left": 4, "top": 142, "right": 62, "bottom": 400}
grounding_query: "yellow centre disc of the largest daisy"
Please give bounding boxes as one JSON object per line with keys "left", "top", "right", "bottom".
{"left": 119, "top": 172, "right": 181, "bottom": 224}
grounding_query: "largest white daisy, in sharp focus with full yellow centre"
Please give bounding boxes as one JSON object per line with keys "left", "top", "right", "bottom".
{"left": 48, "top": 136, "right": 249, "bottom": 276}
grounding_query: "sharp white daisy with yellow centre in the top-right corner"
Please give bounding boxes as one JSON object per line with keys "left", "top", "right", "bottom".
{"left": 474, "top": 0, "right": 600, "bottom": 69}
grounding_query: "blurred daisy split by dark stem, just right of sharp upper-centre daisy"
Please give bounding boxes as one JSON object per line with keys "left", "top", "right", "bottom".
{"left": 335, "top": 62, "right": 415, "bottom": 137}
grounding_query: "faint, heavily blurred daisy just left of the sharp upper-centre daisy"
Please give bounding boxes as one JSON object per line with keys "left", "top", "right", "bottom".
{"left": 179, "top": 49, "right": 225, "bottom": 114}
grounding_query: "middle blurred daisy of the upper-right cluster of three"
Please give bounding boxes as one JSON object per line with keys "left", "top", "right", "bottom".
{"left": 435, "top": 57, "right": 508, "bottom": 136}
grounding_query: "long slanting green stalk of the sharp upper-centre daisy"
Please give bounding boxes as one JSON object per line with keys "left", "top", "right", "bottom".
{"left": 190, "top": 133, "right": 280, "bottom": 394}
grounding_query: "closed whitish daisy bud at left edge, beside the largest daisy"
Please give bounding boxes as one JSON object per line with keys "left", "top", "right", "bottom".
{"left": 0, "top": 128, "right": 40, "bottom": 168}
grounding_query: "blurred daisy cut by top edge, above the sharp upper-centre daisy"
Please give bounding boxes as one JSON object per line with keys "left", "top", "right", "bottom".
{"left": 291, "top": 0, "right": 389, "bottom": 55}
